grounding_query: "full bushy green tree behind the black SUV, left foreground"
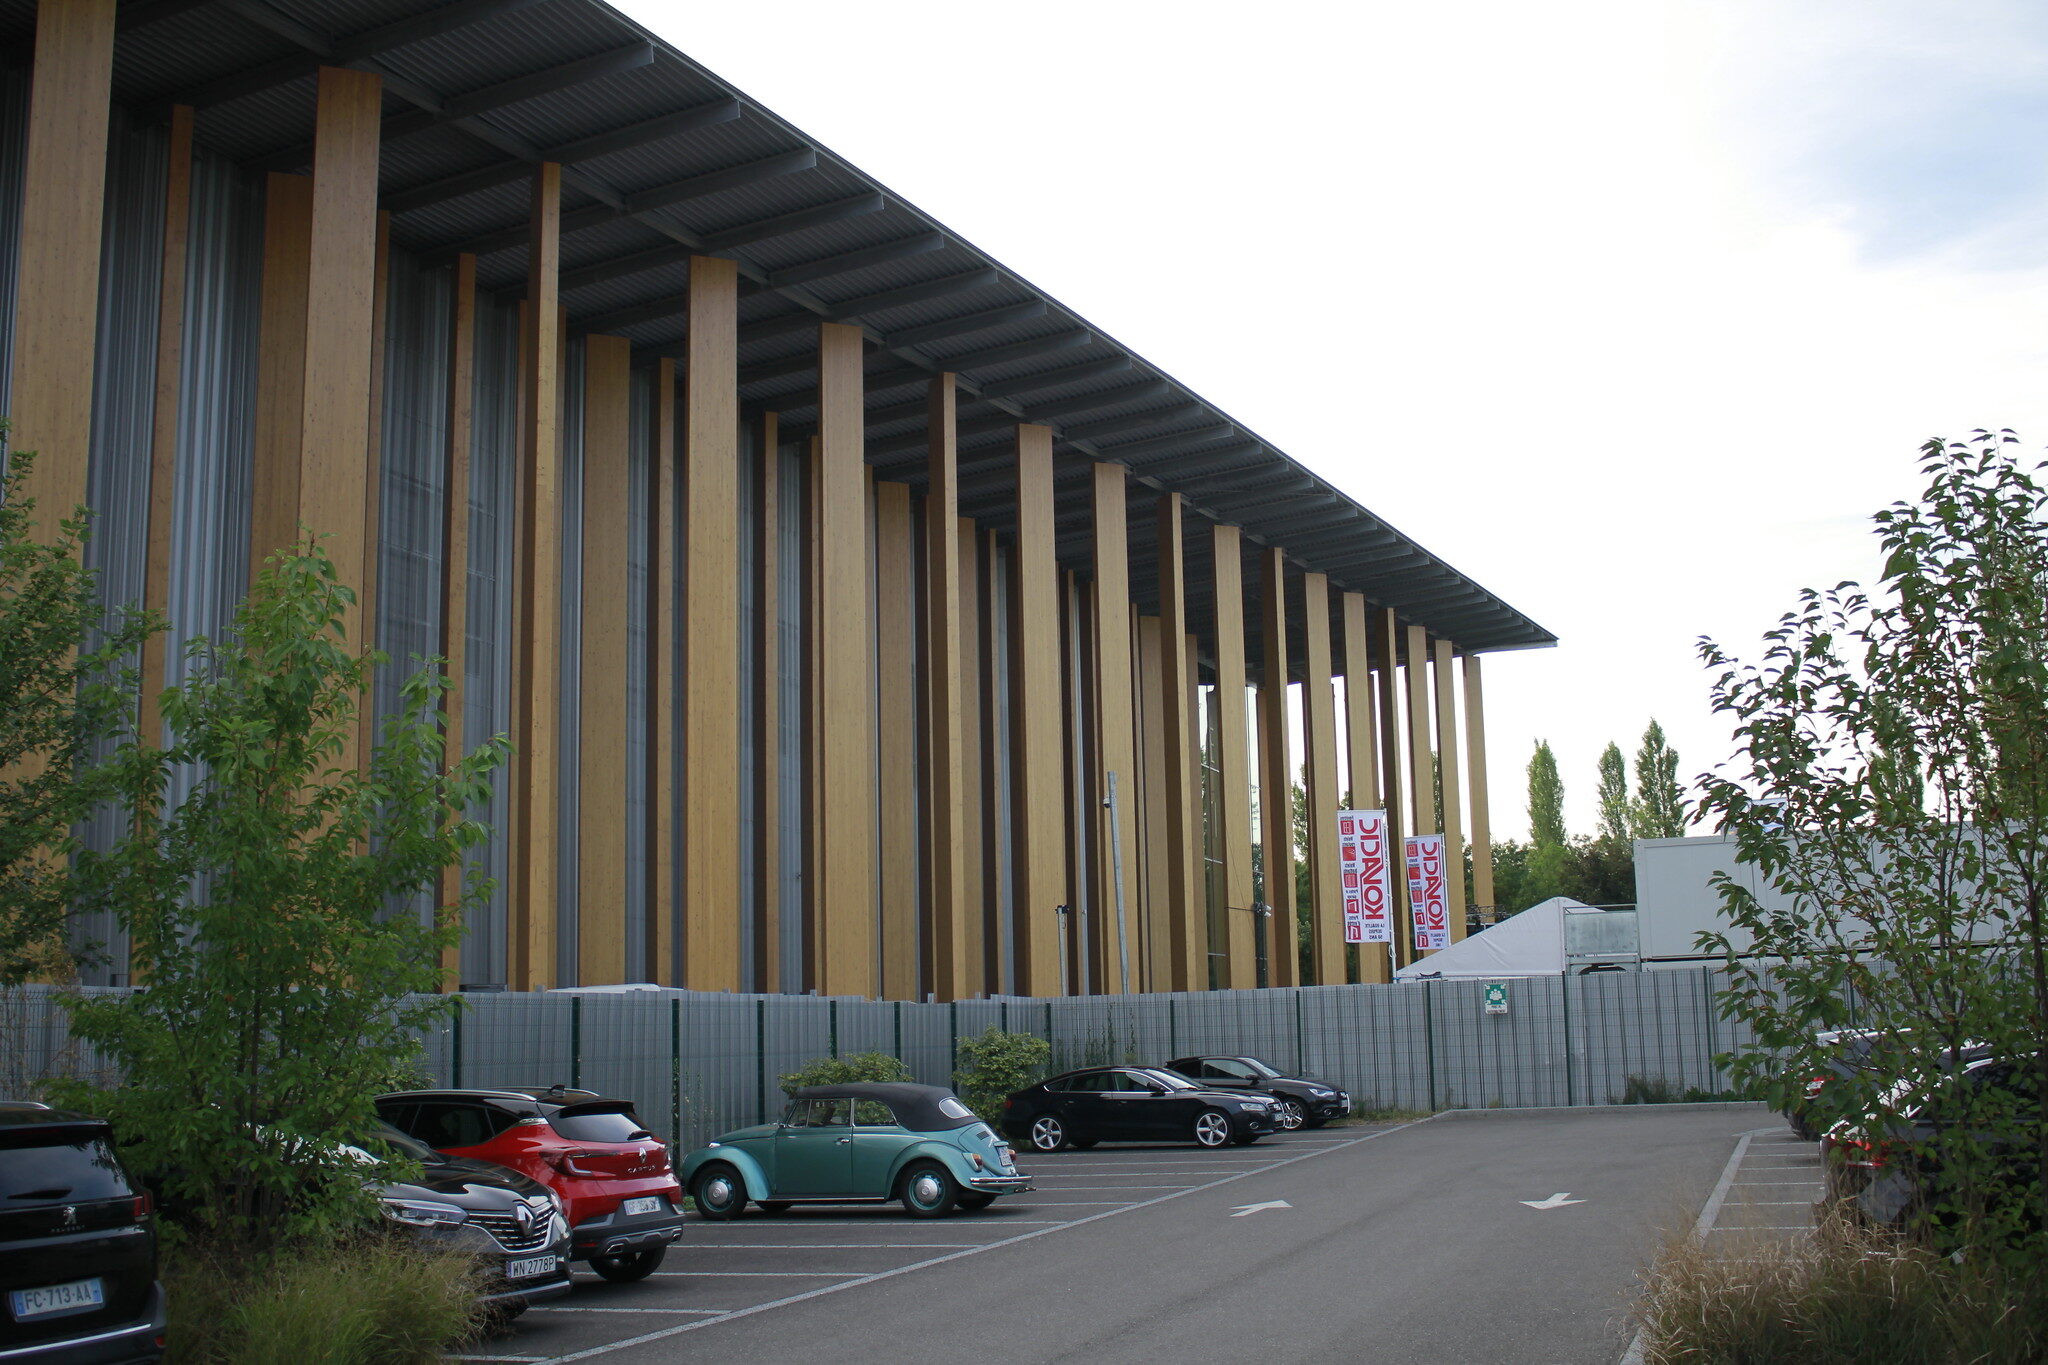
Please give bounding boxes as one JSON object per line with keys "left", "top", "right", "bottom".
{"left": 59, "top": 544, "right": 506, "bottom": 1248}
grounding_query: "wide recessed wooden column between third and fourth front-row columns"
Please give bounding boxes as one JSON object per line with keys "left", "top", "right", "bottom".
{"left": 575, "top": 336, "right": 633, "bottom": 986}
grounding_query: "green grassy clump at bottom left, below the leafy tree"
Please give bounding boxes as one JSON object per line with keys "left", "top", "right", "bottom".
{"left": 164, "top": 1236, "right": 483, "bottom": 1365}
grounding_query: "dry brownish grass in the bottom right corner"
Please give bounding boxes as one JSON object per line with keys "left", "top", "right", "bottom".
{"left": 1634, "top": 1216, "right": 2048, "bottom": 1365}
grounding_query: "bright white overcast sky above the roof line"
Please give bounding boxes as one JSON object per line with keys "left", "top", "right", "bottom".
{"left": 618, "top": 0, "right": 2048, "bottom": 837}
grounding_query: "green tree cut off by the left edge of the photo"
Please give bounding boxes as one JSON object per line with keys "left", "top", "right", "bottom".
{"left": 0, "top": 444, "right": 154, "bottom": 986}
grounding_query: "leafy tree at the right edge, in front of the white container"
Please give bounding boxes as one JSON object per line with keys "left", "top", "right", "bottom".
{"left": 1698, "top": 432, "right": 2048, "bottom": 1267}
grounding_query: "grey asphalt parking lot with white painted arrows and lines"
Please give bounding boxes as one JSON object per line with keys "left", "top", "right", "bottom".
{"left": 455, "top": 1105, "right": 1777, "bottom": 1365}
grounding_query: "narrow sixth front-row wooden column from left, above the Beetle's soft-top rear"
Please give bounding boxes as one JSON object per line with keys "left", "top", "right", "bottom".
{"left": 922, "top": 375, "right": 971, "bottom": 1001}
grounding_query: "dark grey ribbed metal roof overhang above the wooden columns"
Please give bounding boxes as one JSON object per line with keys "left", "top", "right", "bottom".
{"left": 0, "top": 0, "right": 1556, "bottom": 657}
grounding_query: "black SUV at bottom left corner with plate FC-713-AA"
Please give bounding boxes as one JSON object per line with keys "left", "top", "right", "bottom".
{"left": 0, "top": 1101, "right": 164, "bottom": 1365}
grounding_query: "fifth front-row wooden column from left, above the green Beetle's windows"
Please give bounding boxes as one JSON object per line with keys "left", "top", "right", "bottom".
{"left": 817, "top": 323, "right": 874, "bottom": 995}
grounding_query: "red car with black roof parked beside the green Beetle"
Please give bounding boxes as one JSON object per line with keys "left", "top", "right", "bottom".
{"left": 377, "top": 1085, "right": 682, "bottom": 1283}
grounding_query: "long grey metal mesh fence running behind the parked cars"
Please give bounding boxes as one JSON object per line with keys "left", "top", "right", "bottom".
{"left": 0, "top": 968, "right": 1751, "bottom": 1146}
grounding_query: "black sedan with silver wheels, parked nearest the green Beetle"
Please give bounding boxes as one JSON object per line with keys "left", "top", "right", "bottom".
{"left": 1001, "top": 1066, "right": 1278, "bottom": 1152}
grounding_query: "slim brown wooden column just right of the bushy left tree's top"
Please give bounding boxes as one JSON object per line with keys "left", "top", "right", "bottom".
{"left": 438, "top": 252, "right": 477, "bottom": 990}
